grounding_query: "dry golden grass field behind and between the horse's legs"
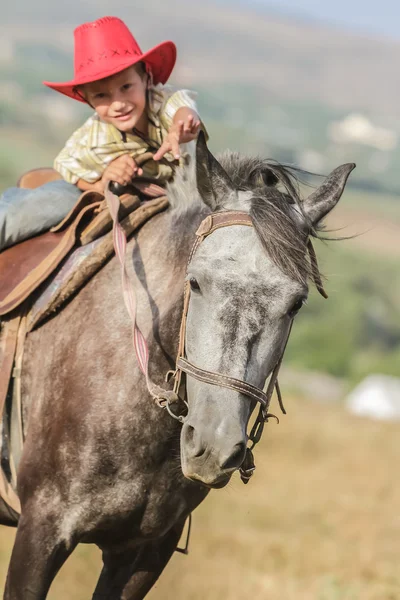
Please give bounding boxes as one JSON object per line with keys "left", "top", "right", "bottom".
{"left": 0, "top": 400, "right": 400, "bottom": 600}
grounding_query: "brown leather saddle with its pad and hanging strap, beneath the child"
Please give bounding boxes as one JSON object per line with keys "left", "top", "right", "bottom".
{"left": 0, "top": 162, "right": 168, "bottom": 520}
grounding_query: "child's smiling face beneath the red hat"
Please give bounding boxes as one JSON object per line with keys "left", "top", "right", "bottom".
{"left": 82, "top": 66, "right": 147, "bottom": 133}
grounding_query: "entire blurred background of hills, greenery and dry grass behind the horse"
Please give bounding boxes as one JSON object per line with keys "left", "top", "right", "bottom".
{"left": 0, "top": 0, "right": 400, "bottom": 600}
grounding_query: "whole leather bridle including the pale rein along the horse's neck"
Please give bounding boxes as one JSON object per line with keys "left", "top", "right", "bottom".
{"left": 105, "top": 186, "right": 327, "bottom": 483}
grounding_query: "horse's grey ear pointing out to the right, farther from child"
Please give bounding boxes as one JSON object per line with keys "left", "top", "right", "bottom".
{"left": 303, "top": 163, "right": 356, "bottom": 227}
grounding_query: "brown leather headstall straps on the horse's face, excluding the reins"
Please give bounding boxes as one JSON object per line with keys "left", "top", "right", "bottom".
{"left": 164, "top": 211, "right": 290, "bottom": 483}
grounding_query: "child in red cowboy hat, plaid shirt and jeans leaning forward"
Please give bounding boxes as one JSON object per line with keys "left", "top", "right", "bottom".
{"left": 0, "top": 17, "right": 201, "bottom": 251}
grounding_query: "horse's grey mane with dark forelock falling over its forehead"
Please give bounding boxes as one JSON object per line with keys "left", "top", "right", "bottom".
{"left": 168, "top": 151, "right": 318, "bottom": 283}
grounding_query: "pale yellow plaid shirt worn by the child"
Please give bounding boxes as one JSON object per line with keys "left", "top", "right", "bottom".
{"left": 54, "top": 84, "right": 197, "bottom": 183}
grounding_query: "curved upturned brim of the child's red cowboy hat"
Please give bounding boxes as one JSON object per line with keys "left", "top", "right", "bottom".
{"left": 43, "top": 41, "right": 176, "bottom": 103}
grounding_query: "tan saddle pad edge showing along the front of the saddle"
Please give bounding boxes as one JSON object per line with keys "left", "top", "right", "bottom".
{"left": 27, "top": 196, "right": 168, "bottom": 331}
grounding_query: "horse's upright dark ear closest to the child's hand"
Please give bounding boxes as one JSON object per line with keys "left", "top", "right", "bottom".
{"left": 196, "top": 131, "right": 235, "bottom": 211}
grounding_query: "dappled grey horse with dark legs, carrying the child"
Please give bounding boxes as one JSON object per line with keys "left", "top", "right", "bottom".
{"left": 1, "top": 135, "right": 355, "bottom": 600}
